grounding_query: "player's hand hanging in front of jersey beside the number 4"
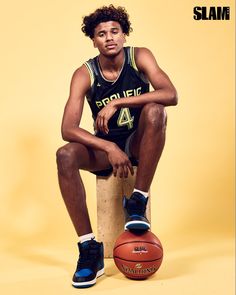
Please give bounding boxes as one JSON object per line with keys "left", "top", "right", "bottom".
{"left": 96, "top": 100, "right": 117, "bottom": 134}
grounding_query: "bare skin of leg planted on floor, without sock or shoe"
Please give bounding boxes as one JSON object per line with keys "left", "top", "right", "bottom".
{"left": 57, "top": 143, "right": 110, "bottom": 236}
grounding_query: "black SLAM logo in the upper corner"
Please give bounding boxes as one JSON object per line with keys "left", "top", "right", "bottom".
{"left": 193, "top": 6, "right": 230, "bottom": 20}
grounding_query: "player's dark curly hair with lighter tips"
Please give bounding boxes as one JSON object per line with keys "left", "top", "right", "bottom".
{"left": 81, "top": 4, "right": 133, "bottom": 39}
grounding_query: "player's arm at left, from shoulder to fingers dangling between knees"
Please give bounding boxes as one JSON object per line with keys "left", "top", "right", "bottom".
{"left": 61, "top": 65, "right": 133, "bottom": 177}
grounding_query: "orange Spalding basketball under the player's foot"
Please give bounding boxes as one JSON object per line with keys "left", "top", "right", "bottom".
{"left": 113, "top": 231, "right": 163, "bottom": 280}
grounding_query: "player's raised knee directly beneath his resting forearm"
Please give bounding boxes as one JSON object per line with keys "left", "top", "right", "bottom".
{"left": 142, "top": 103, "right": 167, "bottom": 129}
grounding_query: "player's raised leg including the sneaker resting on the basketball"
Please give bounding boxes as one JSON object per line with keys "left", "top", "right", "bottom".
{"left": 123, "top": 103, "right": 166, "bottom": 230}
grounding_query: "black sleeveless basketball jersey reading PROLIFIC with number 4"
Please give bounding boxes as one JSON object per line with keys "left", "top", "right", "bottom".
{"left": 84, "top": 47, "right": 149, "bottom": 141}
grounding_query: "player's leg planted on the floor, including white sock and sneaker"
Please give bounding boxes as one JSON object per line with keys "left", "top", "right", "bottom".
{"left": 57, "top": 143, "right": 110, "bottom": 288}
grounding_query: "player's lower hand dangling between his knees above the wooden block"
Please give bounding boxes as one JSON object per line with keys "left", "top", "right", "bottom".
{"left": 107, "top": 144, "right": 134, "bottom": 178}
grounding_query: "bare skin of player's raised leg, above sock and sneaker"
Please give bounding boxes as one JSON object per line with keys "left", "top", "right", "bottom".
{"left": 130, "top": 103, "right": 167, "bottom": 192}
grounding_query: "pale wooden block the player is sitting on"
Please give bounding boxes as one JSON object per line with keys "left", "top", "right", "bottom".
{"left": 96, "top": 167, "right": 151, "bottom": 258}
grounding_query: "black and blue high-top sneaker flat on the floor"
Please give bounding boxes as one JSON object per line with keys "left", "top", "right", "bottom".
{"left": 72, "top": 240, "right": 104, "bottom": 288}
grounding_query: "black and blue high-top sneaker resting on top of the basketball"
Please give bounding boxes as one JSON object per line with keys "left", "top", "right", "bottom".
{"left": 123, "top": 192, "right": 150, "bottom": 230}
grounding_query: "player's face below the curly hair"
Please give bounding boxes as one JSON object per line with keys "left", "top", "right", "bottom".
{"left": 93, "top": 21, "right": 125, "bottom": 56}
